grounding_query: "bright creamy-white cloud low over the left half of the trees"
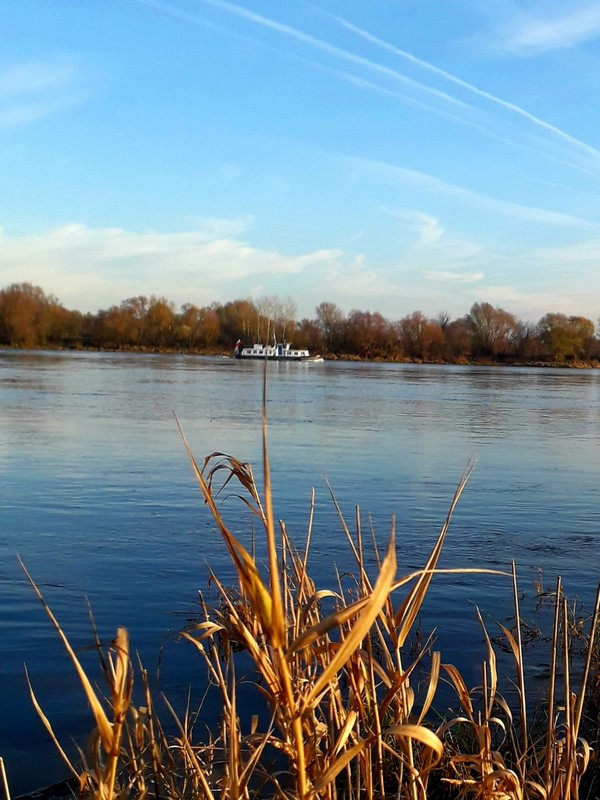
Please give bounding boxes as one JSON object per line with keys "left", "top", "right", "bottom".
{"left": 0, "top": 219, "right": 342, "bottom": 312}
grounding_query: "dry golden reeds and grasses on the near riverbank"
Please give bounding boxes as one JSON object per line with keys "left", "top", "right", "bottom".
{"left": 7, "top": 404, "right": 600, "bottom": 800}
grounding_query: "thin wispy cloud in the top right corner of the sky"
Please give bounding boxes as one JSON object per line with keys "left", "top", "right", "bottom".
{"left": 497, "top": 3, "right": 600, "bottom": 56}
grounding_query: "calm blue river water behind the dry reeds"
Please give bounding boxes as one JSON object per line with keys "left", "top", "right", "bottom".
{"left": 0, "top": 351, "right": 600, "bottom": 794}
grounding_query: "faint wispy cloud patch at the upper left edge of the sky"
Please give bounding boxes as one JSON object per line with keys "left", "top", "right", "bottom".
{"left": 0, "top": 59, "right": 85, "bottom": 128}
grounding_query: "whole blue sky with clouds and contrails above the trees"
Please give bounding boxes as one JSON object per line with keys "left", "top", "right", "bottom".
{"left": 0, "top": 0, "right": 600, "bottom": 321}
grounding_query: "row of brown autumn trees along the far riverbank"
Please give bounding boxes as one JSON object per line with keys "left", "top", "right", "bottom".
{"left": 0, "top": 283, "right": 600, "bottom": 363}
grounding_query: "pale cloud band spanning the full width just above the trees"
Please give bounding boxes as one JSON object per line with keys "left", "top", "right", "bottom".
{"left": 0, "top": 219, "right": 600, "bottom": 320}
